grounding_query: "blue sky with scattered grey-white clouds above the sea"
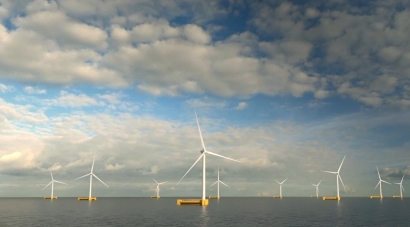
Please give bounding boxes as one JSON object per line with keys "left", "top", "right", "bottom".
{"left": 0, "top": 0, "right": 410, "bottom": 197}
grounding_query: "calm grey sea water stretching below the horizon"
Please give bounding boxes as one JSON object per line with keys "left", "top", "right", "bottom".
{"left": 0, "top": 197, "right": 410, "bottom": 226}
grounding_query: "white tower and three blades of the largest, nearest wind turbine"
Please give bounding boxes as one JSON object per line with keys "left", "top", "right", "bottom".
{"left": 177, "top": 110, "right": 240, "bottom": 206}
